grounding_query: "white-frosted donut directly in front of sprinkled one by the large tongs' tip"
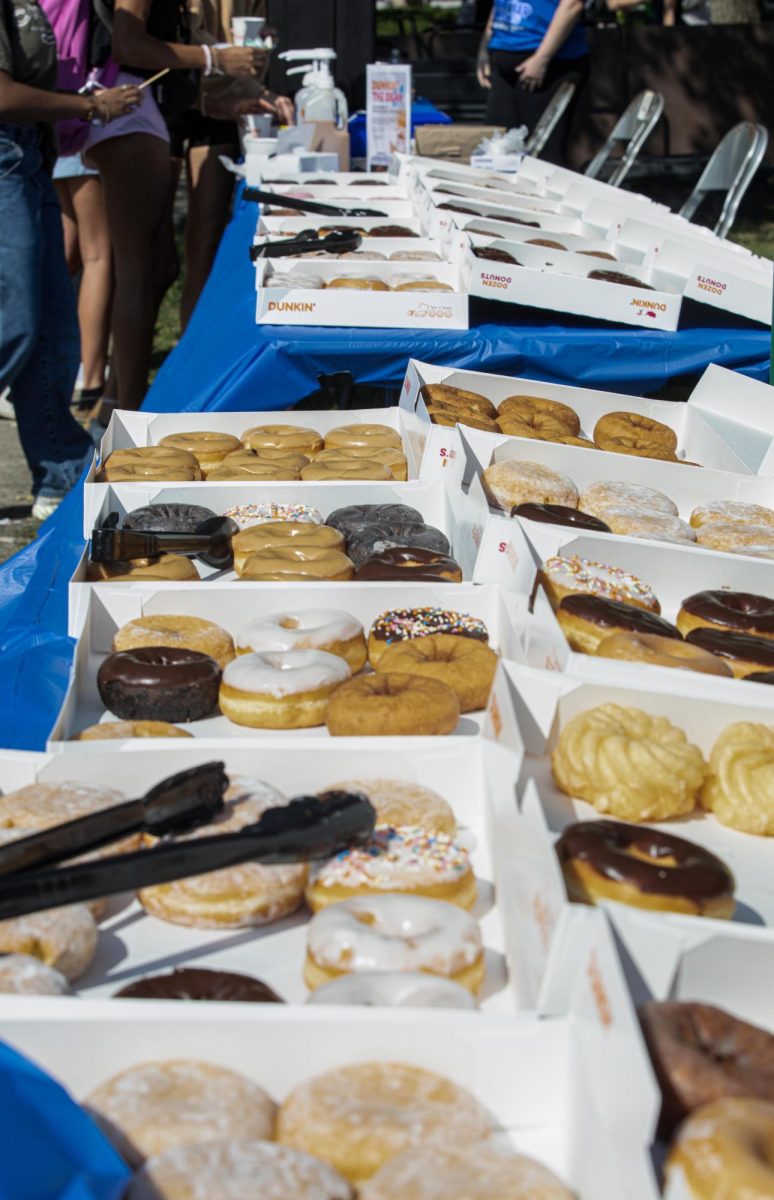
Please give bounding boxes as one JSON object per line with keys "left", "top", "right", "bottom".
{"left": 304, "top": 897, "right": 484, "bottom": 992}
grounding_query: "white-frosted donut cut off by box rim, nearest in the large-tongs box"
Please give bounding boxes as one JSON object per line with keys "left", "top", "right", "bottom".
{"left": 306, "top": 969, "right": 476, "bottom": 1008}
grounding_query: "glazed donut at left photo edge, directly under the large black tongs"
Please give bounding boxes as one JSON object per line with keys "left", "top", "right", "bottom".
{"left": 0, "top": 904, "right": 97, "bottom": 983}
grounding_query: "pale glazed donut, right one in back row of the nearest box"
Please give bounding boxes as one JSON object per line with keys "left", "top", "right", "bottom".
{"left": 276, "top": 1062, "right": 490, "bottom": 1184}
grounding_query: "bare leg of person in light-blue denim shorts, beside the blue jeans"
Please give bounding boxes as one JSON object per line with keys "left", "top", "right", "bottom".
{"left": 70, "top": 175, "right": 113, "bottom": 392}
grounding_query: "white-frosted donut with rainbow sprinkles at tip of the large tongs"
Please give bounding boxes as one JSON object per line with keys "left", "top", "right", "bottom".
{"left": 306, "top": 826, "right": 476, "bottom": 912}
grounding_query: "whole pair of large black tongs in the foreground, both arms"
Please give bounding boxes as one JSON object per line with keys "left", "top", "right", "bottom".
{"left": 0, "top": 762, "right": 376, "bottom": 920}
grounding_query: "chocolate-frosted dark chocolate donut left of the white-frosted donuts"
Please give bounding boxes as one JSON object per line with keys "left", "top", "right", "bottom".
{"left": 97, "top": 646, "right": 222, "bottom": 725}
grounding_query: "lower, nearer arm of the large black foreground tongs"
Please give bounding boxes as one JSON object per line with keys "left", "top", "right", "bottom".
{"left": 0, "top": 787, "right": 376, "bottom": 920}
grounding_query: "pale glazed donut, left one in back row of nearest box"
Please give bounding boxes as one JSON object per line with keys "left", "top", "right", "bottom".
{"left": 84, "top": 1058, "right": 275, "bottom": 1166}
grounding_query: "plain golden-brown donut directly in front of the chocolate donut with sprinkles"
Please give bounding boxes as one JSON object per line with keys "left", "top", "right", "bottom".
{"left": 376, "top": 634, "right": 498, "bottom": 713}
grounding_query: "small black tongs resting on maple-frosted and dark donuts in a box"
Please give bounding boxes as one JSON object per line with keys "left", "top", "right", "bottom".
{"left": 91, "top": 512, "right": 239, "bottom": 570}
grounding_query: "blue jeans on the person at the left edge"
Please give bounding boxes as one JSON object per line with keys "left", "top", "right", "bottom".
{"left": 0, "top": 122, "right": 91, "bottom": 496}
